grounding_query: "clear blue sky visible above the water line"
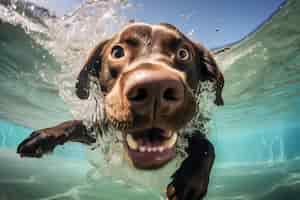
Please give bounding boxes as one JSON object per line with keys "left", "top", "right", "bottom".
{"left": 32, "top": 0, "right": 285, "bottom": 48}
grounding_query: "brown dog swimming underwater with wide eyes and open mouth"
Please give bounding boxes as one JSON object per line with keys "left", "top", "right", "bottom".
{"left": 18, "top": 23, "right": 224, "bottom": 200}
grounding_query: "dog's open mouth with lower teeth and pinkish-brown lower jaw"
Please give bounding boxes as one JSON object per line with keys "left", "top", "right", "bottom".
{"left": 125, "top": 128, "right": 177, "bottom": 169}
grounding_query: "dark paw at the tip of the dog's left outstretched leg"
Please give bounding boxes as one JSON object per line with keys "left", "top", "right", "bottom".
{"left": 17, "top": 130, "right": 64, "bottom": 158}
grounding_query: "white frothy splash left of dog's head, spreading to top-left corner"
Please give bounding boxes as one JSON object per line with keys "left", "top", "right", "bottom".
{"left": 0, "top": 0, "right": 131, "bottom": 119}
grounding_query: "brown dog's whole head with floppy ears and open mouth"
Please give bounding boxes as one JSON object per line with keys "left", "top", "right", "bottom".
{"left": 76, "top": 23, "right": 224, "bottom": 169}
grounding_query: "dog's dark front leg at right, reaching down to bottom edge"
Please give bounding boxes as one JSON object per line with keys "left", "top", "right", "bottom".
{"left": 167, "top": 133, "right": 215, "bottom": 200}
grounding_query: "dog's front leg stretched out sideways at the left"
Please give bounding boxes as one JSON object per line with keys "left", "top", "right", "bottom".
{"left": 17, "top": 120, "right": 96, "bottom": 157}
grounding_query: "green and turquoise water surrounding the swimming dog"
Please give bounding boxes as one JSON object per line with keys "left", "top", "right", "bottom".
{"left": 0, "top": 0, "right": 300, "bottom": 200}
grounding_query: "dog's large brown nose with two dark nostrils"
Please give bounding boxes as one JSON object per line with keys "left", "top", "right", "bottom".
{"left": 124, "top": 68, "right": 184, "bottom": 117}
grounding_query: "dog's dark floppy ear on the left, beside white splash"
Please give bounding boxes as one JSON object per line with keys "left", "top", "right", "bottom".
{"left": 75, "top": 40, "right": 110, "bottom": 99}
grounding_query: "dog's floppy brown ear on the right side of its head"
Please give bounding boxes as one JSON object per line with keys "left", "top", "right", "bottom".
{"left": 195, "top": 44, "right": 224, "bottom": 106}
